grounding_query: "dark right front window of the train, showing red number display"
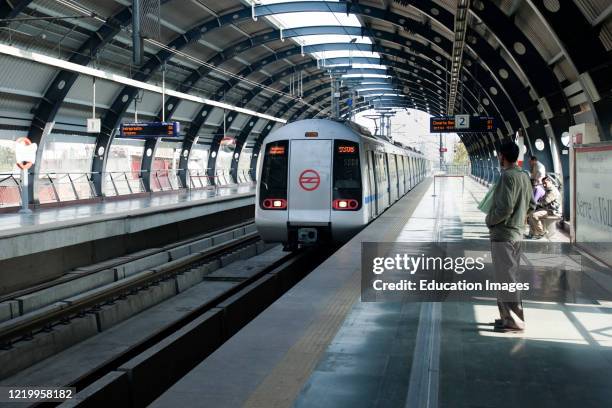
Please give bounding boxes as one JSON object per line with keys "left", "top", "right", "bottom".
{"left": 333, "top": 140, "right": 361, "bottom": 210}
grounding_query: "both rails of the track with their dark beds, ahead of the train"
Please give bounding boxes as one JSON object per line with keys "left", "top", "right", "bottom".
{"left": 0, "top": 222, "right": 332, "bottom": 406}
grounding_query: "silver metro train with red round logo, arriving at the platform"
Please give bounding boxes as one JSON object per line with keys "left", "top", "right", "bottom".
{"left": 255, "top": 119, "right": 428, "bottom": 250}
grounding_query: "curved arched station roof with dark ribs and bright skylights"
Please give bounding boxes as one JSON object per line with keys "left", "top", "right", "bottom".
{"left": 0, "top": 0, "right": 612, "bottom": 197}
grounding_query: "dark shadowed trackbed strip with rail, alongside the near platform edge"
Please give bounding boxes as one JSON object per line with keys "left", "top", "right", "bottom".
{"left": 55, "top": 249, "right": 329, "bottom": 407}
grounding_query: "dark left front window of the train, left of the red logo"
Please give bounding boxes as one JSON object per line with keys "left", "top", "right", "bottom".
{"left": 259, "top": 140, "right": 289, "bottom": 209}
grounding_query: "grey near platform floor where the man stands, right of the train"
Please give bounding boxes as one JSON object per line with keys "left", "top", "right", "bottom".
{"left": 151, "top": 177, "right": 612, "bottom": 408}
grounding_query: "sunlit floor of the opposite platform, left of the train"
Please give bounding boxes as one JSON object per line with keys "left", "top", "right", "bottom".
{"left": 0, "top": 185, "right": 255, "bottom": 236}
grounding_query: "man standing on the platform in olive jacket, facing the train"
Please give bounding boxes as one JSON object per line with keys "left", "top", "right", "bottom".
{"left": 485, "top": 141, "right": 535, "bottom": 331}
